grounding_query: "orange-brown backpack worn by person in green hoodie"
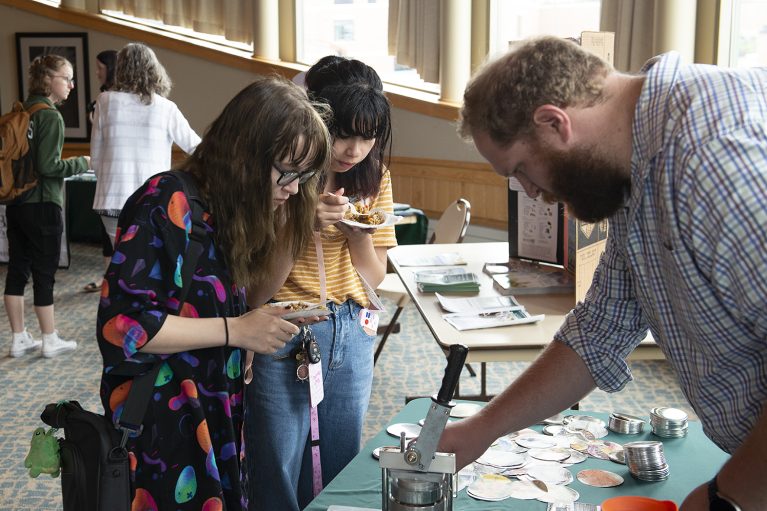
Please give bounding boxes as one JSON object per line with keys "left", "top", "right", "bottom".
{"left": 0, "top": 101, "right": 51, "bottom": 205}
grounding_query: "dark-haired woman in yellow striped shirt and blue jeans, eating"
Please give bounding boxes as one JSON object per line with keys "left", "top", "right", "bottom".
{"left": 245, "top": 57, "right": 397, "bottom": 511}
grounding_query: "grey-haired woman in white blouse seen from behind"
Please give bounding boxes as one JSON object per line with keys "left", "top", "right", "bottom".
{"left": 91, "top": 43, "right": 200, "bottom": 245}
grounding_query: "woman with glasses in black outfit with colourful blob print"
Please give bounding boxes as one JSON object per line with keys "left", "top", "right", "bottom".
{"left": 97, "top": 77, "right": 330, "bottom": 510}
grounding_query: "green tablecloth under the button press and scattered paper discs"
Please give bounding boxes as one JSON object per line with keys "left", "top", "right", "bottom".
{"left": 306, "top": 399, "right": 729, "bottom": 511}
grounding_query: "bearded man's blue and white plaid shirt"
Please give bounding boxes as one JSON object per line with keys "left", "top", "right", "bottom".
{"left": 556, "top": 53, "right": 767, "bottom": 452}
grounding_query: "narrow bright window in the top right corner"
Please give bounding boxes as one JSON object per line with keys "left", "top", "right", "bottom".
{"left": 728, "top": 0, "right": 767, "bottom": 67}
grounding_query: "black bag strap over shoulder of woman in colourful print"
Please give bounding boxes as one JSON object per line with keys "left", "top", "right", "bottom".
{"left": 114, "top": 170, "right": 207, "bottom": 438}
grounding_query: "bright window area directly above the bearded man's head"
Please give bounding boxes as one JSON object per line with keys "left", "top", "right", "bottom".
{"left": 489, "top": 0, "right": 601, "bottom": 55}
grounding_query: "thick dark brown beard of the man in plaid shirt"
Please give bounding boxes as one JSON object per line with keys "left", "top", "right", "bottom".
{"left": 539, "top": 142, "right": 631, "bottom": 223}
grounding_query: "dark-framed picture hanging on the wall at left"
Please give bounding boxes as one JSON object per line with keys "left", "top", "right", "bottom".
{"left": 16, "top": 32, "right": 90, "bottom": 142}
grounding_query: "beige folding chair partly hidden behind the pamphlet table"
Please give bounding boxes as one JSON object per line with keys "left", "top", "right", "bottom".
{"left": 373, "top": 198, "right": 471, "bottom": 364}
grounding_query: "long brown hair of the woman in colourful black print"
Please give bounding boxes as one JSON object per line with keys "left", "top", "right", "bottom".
{"left": 180, "top": 76, "right": 331, "bottom": 288}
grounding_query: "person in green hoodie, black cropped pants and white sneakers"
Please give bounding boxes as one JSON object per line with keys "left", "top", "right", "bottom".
{"left": 3, "top": 55, "right": 89, "bottom": 357}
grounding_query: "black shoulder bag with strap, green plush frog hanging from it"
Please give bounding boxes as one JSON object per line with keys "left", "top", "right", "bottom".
{"left": 40, "top": 171, "right": 206, "bottom": 511}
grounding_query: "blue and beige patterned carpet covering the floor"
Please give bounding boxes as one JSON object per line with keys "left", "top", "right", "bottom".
{"left": 0, "top": 243, "right": 695, "bottom": 511}
